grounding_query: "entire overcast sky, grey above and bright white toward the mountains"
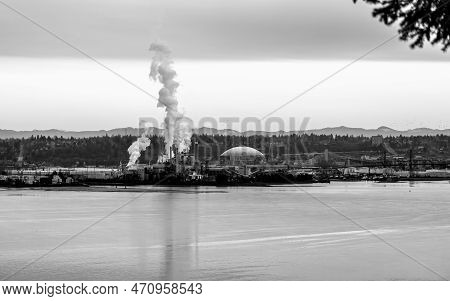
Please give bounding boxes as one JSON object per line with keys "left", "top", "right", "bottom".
{"left": 0, "top": 0, "right": 450, "bottom": 130}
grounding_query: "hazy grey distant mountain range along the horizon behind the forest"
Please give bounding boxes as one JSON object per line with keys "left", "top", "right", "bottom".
{"left": 0, "top": 126, "right": 450, "bottom": 139}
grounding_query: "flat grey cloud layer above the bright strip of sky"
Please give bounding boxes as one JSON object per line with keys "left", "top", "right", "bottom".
{"left": 0, "top": 0, "right": 448, "bottom": 60}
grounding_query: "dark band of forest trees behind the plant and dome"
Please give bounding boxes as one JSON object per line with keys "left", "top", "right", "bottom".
{"left": 0, "top": 134, "right": 450, "bottom": 169}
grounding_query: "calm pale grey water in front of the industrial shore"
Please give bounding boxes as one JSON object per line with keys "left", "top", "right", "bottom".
{"left": 0, "top": 182, "right": 450, "bottom": 280}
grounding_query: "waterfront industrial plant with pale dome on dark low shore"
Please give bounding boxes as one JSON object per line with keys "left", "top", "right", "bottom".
{"left": 0, "top": 146, "right": 327, "bottom": 186}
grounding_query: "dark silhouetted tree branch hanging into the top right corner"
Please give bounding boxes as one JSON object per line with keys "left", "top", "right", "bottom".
{"left": 353, "top": 0, "right": 450, "bottom": 51}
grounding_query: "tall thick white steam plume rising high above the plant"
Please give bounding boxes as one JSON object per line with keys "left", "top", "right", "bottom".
{"left": 150, "top": 43, "right": 192, "bottom": 155}
